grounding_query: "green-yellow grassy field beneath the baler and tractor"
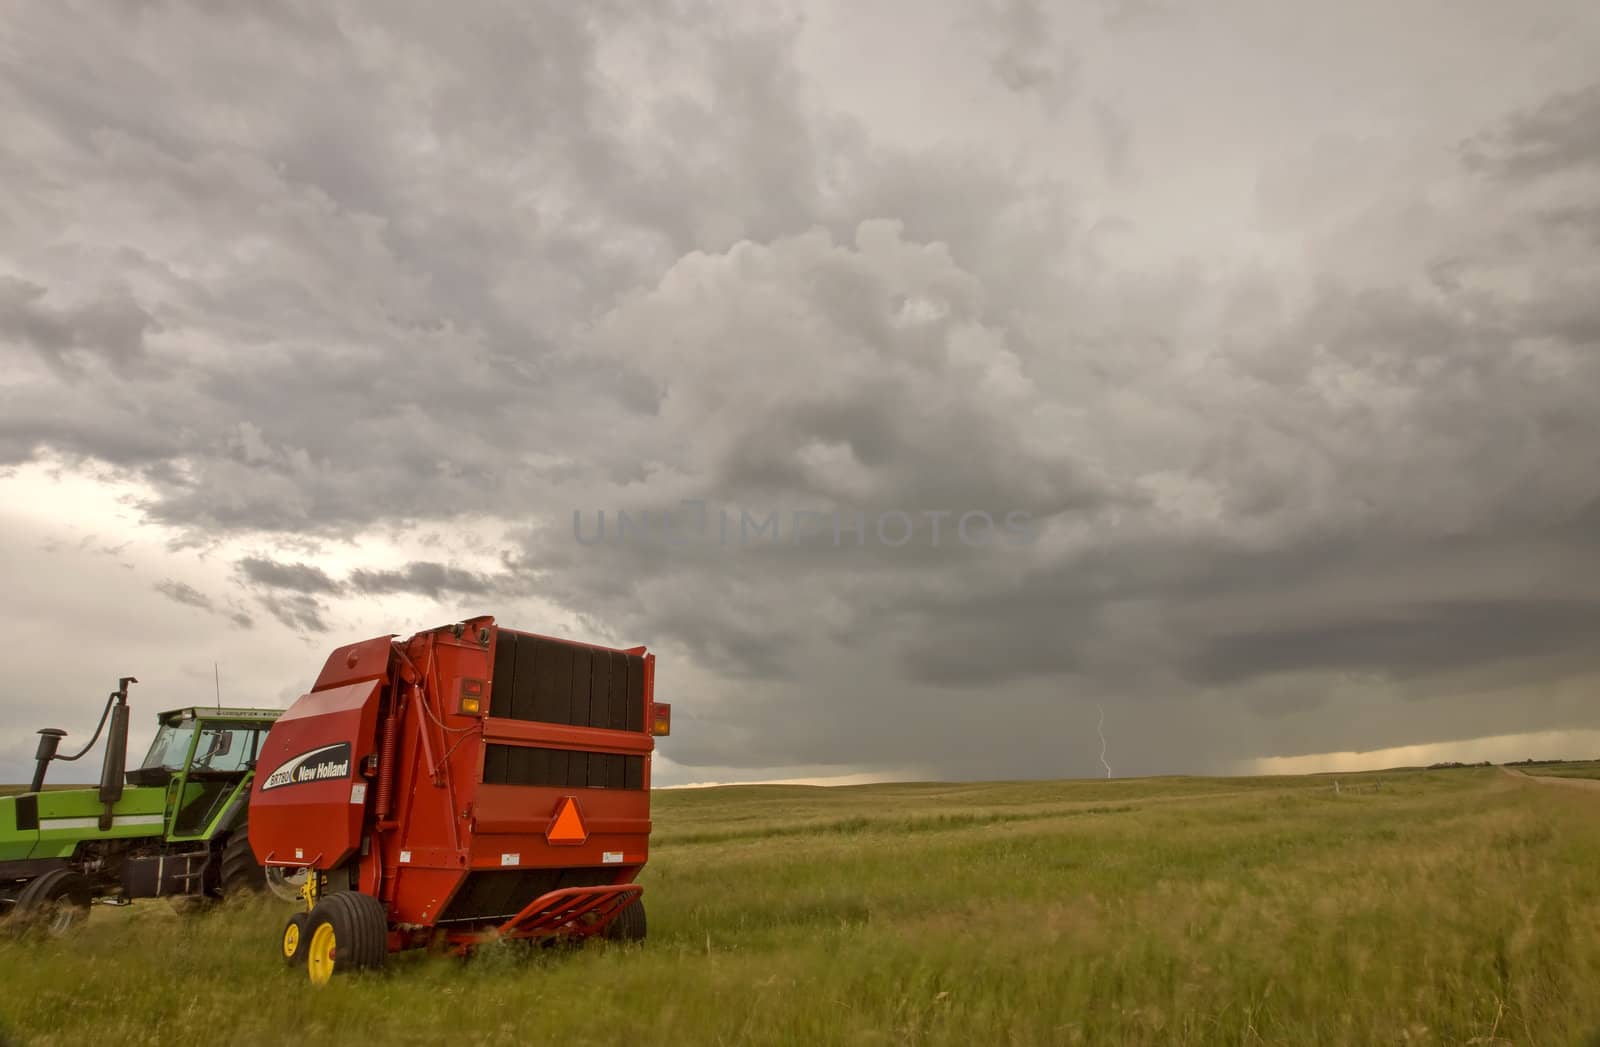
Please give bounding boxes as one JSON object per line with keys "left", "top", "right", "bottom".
{"left": 0, "top": 768, "right": 1600, "bottom": 1047}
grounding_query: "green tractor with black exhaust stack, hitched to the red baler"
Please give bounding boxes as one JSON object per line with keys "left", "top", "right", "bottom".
{"left": 0, "top": 677, "right": 298, "bottom": 935}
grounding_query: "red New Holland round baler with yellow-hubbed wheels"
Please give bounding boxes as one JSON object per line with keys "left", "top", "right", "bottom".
{"left": 250, "top": 616, "right": 670, "bottom": 981}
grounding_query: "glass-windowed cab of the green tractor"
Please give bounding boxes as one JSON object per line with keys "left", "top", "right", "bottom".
{"left": 126, "top": 706, "right": 277, "bottom": 840}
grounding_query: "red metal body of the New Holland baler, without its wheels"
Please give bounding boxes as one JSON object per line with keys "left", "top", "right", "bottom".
{"left": 250, "top": 616, "right": 654, "bottom": 948}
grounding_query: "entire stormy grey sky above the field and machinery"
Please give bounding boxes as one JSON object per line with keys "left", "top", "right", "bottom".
{"left": 0, "top": 0, "right": 1600, "bottom": 783}
